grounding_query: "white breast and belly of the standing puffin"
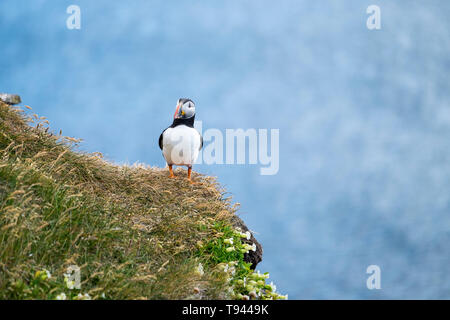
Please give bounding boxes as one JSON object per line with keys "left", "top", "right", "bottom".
{"left": 163, "top": 125, "right": 201, "bottom": 166}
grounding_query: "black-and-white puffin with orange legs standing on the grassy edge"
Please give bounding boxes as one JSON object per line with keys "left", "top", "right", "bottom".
{"left": 159, "top": 98, "right": 203, "bottom": 183}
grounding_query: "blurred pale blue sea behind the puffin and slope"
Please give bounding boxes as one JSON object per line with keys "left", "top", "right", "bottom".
{"left": 0, "top": 0, "right": 450, "bottom": 299}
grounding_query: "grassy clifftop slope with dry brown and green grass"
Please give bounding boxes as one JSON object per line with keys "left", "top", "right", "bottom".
{"left": 0, "top": 102, "right": 284, "bottom": 299}
